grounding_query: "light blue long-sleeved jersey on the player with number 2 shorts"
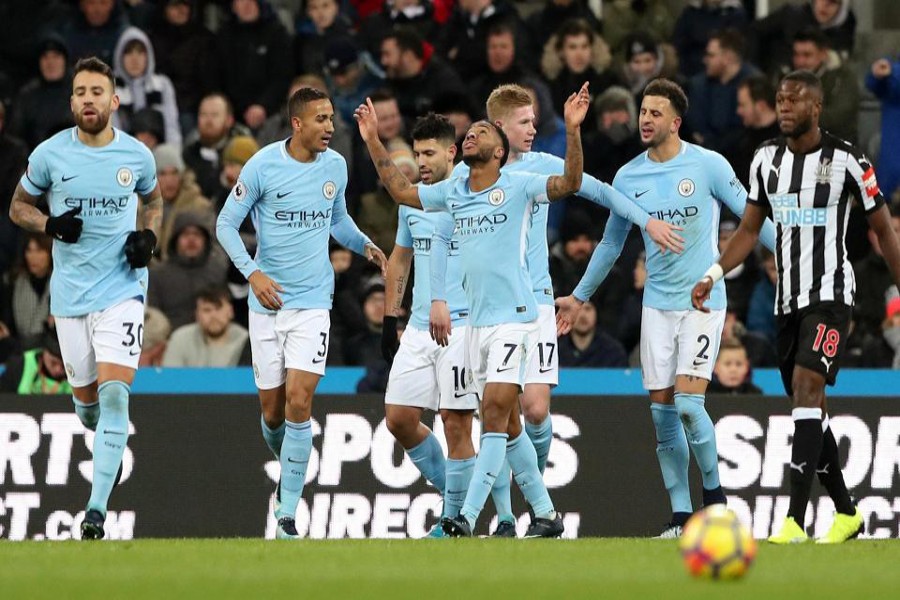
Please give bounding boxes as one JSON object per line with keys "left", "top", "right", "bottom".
{"left": 574, "top": 141, "right": 775, "bottom": 310}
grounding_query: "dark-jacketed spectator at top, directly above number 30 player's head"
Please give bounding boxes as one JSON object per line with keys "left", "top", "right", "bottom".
{"left": 62, "top": 0, "right": 128, "bottom": 65}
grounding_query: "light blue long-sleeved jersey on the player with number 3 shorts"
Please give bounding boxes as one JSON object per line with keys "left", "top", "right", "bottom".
{"left": 216, "top": 141, "right": 371, "bottom": 313}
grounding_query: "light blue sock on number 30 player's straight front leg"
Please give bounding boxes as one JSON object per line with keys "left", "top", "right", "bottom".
{"left": 87, "top": 381, "right": 131, "bottom": 516}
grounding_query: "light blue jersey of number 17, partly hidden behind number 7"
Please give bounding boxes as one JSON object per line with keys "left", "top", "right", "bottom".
{"left": 453, "top": 152, "right": 650, "bottom": 306}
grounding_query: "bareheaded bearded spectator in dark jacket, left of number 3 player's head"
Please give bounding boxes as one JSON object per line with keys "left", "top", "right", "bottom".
{"left": 182, "top": 93, "right": 250, "bottom": 198}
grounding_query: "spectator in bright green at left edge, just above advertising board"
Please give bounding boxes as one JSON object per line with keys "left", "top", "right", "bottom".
{"left": 0, "top": 328, "right": 72, "bottom": 395}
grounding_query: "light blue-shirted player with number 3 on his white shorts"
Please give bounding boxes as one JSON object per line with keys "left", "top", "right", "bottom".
{"left": 216, "top": 88, "right": 387, "bottom": 539}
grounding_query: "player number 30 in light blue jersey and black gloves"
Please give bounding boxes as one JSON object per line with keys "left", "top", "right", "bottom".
{"left": 9, "top": 58, "right": 162, "bottom": 539}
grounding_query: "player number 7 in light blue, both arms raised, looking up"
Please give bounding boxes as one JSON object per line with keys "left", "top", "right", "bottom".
{"left": 356, "top": 84, "right": 590, "bottom": 537}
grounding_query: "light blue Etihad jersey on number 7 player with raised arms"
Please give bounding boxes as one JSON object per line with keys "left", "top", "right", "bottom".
{"left": 417, "top": 172, "right": 549, "bottom": 327}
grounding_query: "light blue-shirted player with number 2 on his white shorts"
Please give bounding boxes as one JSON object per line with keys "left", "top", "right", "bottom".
{"left": 556, "top": 79, "right": 775, "bottom": 538}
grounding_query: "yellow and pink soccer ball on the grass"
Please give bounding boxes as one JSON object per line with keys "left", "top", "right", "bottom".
{"left": 679, "top": 504, "right": 756, "bottom": 579}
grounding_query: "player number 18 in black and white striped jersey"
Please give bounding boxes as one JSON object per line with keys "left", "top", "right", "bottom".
{"left": 692, "top": 71, "right": 900, "bottom": 544}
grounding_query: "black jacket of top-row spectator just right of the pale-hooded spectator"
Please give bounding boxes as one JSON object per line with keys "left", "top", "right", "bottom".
{"left": 150, "top": 6, "right": 216, "bottom": 114}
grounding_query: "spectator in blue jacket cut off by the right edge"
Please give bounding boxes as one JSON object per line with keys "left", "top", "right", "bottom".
{"left": 866, "top": 57, "right": 900, "bottom": 204}
